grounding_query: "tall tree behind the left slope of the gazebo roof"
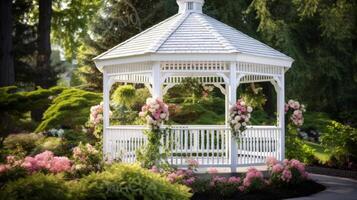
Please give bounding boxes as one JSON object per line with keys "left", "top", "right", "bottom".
{"left": 78, "top": 0, "right": 177, "bottom": 90}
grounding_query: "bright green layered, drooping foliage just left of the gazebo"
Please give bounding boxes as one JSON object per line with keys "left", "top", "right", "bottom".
{"left": 36, "top": 89, "right": 102, "bottom": 132}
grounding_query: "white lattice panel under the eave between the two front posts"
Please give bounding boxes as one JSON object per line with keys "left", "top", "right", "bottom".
{"left": 161, "top": 61, "right": 229, "bottom": 72}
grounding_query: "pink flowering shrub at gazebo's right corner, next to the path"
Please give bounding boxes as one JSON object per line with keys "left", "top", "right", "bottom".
{"left": 267, "top": 158, "right": 308, "bottom": 186}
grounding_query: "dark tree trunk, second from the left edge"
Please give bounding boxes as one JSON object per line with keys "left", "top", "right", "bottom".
{"left": 36, "top": 0, "right": 52, "bottom": 88}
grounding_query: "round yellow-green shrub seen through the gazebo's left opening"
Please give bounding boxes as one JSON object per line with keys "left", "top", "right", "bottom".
{"left": 112, "top": 85, "right": 136, "bottom": 108}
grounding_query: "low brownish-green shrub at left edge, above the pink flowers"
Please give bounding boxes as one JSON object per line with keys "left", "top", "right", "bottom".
{"left": 4, "top": 133, "right": 44, "bottom": 154}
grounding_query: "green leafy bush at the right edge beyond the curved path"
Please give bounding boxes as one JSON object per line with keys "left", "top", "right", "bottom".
{"left": 321, "top": 121, "right": 357, "bottom": 165}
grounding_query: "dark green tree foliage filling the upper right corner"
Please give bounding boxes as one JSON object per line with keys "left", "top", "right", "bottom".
{"left": 247, "top": 0, "right": 357, "bottom": 125}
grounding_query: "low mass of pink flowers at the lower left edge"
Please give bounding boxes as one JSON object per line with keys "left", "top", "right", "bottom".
{"left": 0, "top": 151, "right": 71, "bottom": 177}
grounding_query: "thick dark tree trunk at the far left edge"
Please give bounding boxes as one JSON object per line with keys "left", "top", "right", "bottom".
{"left": 0, "top": 0, "right": 15, "bottom": 87}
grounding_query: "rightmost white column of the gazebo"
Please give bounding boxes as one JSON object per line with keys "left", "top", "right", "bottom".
{"left": 278, "top": 71, "right": 285, "bottom": 160}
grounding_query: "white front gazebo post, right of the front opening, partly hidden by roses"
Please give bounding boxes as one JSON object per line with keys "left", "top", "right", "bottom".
{"left": 226, "top": 62, "right": 238, "bottom": 172}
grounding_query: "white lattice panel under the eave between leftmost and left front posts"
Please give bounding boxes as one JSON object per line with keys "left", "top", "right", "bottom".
{"left": 104, "top": 62, "right": 152, "bottom": 74}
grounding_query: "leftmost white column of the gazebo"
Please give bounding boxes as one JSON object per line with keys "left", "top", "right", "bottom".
{"left": 103, "top": 70, "right": 110, "bottom": 156}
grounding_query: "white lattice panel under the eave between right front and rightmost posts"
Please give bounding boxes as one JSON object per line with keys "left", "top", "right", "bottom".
{"left": 237, "top": 62, "right": 283, "bottom": 75}
